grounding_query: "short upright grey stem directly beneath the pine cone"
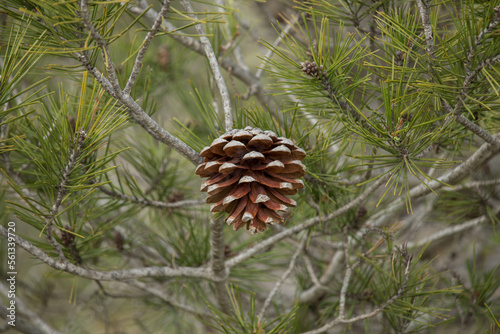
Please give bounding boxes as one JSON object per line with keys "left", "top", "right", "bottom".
{"left": 210, "top": 219, "right": 231, "bottom": 314}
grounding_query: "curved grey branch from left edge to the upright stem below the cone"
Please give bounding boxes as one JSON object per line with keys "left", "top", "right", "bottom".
{"left": 0, "top": 226, "right": 220, "bottom": 282}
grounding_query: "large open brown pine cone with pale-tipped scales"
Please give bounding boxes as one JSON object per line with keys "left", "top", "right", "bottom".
{"left": 196, "top": 127, "right": 306, "bottom": 233}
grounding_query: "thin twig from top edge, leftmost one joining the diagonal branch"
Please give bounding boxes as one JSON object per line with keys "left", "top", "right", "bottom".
{"left": 80, "top": 0, "right": 121, "bottom": 94}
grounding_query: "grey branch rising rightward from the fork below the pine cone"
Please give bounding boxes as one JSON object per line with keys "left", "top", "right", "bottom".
{"left": 226, "top": 174, "right": 390, "bottom": 268}
